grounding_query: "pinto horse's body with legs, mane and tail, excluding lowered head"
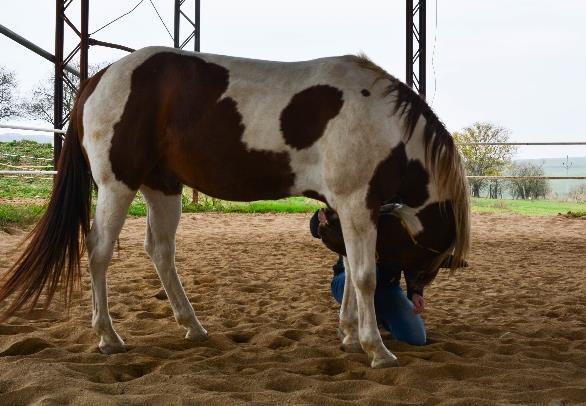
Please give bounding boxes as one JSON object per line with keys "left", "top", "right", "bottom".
{"left": 0, "top": 47, "right": 469, "bottom": 367}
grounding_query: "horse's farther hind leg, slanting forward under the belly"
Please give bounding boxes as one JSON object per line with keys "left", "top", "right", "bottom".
{"left": 141, "top": 186, "right": 207, "bottom": 340}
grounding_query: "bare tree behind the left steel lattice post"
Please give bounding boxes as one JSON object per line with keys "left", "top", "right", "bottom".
{"left": 21, "top": 64, "right": 104, "bottom": 126}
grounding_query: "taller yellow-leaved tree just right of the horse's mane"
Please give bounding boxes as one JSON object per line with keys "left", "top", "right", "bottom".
{"left": 453, "top": 122, "right": 515, "bottom": 198}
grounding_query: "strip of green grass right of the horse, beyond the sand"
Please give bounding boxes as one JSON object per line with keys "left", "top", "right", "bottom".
{"left": 472, "top": 198, "right": 586, "bottom": 217}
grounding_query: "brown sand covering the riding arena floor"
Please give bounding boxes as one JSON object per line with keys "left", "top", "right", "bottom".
{"left": 0, "top": 214, "right": 586, "bottom": 405}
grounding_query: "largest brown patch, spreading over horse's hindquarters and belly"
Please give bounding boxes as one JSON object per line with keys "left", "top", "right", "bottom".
{"left": 110, "top": 52, "right": 295, "bottom": 200}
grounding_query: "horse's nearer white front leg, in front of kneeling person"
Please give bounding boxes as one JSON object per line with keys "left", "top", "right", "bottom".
{"left": 338, "top": 206, "right": 398, "bottom": 368}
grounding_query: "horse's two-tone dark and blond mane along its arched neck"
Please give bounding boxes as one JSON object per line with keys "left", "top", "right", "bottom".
{"left": 352, "top": 54, "right": 470, "bottom": 272}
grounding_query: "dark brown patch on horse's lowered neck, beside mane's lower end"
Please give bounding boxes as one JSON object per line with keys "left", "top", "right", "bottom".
{"left": 415, "top": 201, "right": 456, "bottom": 251}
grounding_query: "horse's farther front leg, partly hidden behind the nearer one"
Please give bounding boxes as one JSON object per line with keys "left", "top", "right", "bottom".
{"left": 340, "top": 257, "right": 362, "bottom": 352}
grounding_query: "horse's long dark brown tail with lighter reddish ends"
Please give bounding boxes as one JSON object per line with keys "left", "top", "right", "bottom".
{"left": 0, "top": 101, "right": 92, "bottom": 320}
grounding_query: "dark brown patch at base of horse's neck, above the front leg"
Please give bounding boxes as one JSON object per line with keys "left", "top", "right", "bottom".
{"left": 366, "top": 143, "right": 429, "bottom": 224}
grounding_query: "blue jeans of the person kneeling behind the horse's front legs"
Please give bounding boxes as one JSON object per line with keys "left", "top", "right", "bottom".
{"left": 331, "top": 268, "right": 427, "bottom": 345}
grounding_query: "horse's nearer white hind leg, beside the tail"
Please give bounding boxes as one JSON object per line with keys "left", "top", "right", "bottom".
{"left": 87, "top": 184, "right": 136, "bottom": 354}
